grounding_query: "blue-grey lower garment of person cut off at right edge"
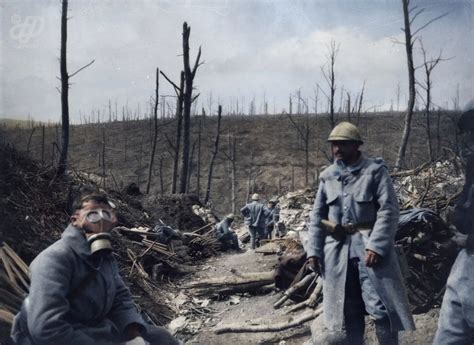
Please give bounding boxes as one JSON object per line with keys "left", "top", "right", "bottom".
{"left": 434, "top": 249, "right": 474, "bottom": 345}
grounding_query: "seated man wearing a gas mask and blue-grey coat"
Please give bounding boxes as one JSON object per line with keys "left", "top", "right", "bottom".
{"left": 12, "top": 194, "right": 180, "bottom": 345}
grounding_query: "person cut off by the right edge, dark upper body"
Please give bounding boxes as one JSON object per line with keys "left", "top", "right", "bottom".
{"left": 434, "top": 99, "right": 474, "bottom": 345}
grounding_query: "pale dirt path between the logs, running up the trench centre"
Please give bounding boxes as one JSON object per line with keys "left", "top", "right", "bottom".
{"left": 183, "top": 251, "right": 310, "bottom": 345}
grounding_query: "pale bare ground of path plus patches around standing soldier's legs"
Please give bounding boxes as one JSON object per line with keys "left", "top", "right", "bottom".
{"left": 172, "top": 250, "right": 438, "bottom": 345}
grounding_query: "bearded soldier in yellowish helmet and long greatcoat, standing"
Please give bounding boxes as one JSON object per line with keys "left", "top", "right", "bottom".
{"left": 307, "top": 122, "right": 415, "bottom": 345}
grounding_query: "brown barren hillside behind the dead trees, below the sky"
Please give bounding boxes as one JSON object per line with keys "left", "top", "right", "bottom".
{"left": 3, "top": 113, "right": 457, "bottom": 214}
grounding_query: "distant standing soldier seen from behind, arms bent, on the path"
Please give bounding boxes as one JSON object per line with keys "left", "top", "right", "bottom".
{"left": 240, "top": 193, "right": 267, "bottom": 249}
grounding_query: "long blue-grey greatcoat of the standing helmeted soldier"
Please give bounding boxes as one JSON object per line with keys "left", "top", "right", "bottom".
{"left": 307, "top": 155, "right": 414, "bottom": 331}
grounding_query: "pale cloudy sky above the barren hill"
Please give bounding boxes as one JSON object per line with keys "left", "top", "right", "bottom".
{"left": 0, "top": 0, "right": 474, "bottom": 122}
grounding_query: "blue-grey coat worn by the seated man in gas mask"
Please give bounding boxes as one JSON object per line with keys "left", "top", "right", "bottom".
{"left": 12, "top": 225, "right": 147, "bottom": 345}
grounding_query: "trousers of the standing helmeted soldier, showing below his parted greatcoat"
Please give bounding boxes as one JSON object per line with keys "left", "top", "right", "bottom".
{"left": 344, "top": 259, "right": 398, "bottom": 345}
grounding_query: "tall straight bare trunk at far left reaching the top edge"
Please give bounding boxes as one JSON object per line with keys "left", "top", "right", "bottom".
{"left": 57, "top": 0, "right": 69, "bottom": 176}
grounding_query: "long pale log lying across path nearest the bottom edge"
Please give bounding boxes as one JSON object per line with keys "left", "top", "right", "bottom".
{"left": 214, "top": 308, "right": 323, "bottom": 334}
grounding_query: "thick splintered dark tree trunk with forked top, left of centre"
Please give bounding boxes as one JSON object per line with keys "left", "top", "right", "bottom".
{"left": 179, "top": 22, "right": 201, "bottom": 193}
